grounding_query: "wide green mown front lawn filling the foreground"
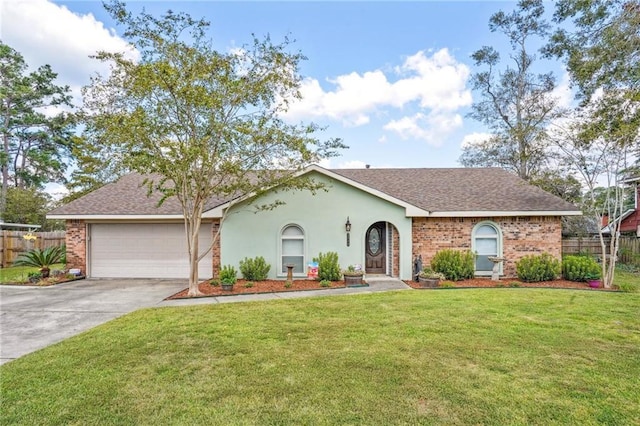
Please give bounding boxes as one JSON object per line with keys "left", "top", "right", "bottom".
{"left": 0, "top": 288, "right": 640, "bottom": 425}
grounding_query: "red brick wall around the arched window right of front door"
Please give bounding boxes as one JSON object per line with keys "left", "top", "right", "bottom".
{"left": 412, "top": 216, "right": 562, "bottom": 277}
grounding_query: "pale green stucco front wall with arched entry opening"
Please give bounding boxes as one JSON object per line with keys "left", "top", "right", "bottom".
{"left": 220, "top": 173, "right": 411, "bottom": 279}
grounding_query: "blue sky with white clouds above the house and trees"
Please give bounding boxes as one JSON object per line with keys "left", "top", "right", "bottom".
{"left": 0, "top": 0, "right": 569, "bottom": 176}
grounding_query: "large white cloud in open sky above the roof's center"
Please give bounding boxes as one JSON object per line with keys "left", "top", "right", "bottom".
{"left": 287, "top": 49, "right": 471, "bottom": 126}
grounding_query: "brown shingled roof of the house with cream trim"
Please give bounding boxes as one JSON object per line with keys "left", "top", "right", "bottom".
{"left": 47, "top": 165, "right": 581, "bottom": 219}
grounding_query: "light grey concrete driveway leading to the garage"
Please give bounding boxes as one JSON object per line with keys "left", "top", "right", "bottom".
{"left": 0, "top": 279, "right": 187, "bottom": 364}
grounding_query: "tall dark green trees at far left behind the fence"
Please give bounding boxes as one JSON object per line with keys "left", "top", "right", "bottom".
{"left": 0, "top": 41, "right": 74, "bottom": 216}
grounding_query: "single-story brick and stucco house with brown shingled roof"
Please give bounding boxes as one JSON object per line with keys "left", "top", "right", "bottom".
{"left": 47, "top": 165, "right": 581, "bottom": 280}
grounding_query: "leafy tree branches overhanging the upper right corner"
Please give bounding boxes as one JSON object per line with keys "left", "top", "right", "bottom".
{"left": 545, "top": 0, "right": 640, "bottom": 155}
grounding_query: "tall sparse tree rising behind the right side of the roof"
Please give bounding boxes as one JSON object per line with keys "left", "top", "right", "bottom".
{"left": 460, "top": 0, "right": 560, "bottom": 180}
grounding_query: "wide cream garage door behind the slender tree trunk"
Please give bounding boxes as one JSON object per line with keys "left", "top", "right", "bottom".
{"left": 89, "top": 223, "right": 211, "bottom": 279}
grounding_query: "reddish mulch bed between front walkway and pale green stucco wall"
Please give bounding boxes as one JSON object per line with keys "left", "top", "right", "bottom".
{"left": 167, "top": 280, "right": 345, "bottom": 300}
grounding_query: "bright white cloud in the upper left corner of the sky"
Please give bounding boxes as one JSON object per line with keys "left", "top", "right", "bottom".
{"left": 0, "top": 0, "right": 137, "bottom": 101}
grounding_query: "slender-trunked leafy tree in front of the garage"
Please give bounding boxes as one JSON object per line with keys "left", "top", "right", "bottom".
{"left": 84, "top": 1, "right": 344, "bottom": 295}
